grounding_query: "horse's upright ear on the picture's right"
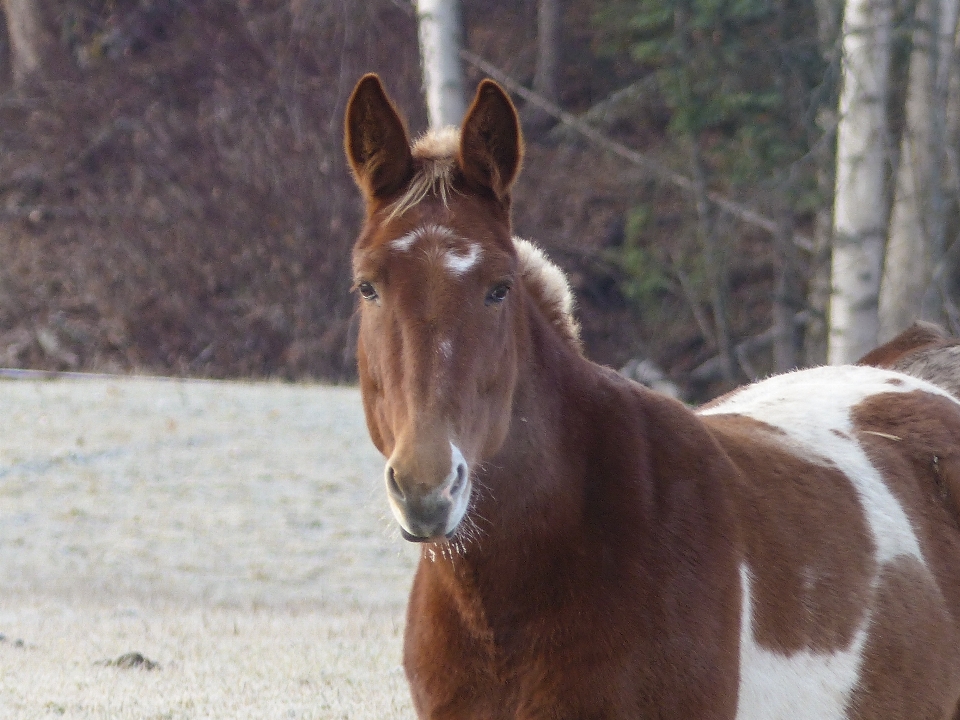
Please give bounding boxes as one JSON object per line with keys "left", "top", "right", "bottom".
{"left": 460, "top": 80, "right": 523, "bottom": 200}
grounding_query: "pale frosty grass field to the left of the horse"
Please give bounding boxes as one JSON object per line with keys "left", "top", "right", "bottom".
{"left": 0, "top": 379, "right": 416, "bottom": 720}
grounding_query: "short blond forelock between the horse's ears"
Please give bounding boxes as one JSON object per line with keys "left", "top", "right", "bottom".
{"left": 387, "top": 127, "right": 460, "bottom": 220}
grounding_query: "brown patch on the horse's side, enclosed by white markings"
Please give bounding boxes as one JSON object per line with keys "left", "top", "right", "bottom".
{"left": 703, "top": 415, "right": 876, "bottom": 655}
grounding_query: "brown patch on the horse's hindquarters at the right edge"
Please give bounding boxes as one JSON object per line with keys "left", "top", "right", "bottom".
{"left": 852, "top": 391, "right": 960, "bottom": 719}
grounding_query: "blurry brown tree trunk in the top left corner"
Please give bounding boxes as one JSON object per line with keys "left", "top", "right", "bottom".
{"left": 2, "top": 0, "right": 66, "bottom": 86}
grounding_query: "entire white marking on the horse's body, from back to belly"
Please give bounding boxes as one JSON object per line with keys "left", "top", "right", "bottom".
{"left": 700, "top": 366, "right": 950, "bottom": 720}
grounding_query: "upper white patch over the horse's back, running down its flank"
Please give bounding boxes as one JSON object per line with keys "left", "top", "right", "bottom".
{"left": 701, "top": 366, "right": 951, "bottom": 566}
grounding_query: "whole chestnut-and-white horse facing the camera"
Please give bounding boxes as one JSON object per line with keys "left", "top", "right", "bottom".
{"left": 346, "top": 75, "right": 960, "bottom": 720}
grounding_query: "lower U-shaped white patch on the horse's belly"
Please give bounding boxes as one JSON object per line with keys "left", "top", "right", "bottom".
{"left": 736, "top": 564, "right": 870, "bottom": 720}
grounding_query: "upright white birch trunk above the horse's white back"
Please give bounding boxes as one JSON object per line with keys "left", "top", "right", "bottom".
{"left": 827, "top": 0, "right": 893, "bottom": 365}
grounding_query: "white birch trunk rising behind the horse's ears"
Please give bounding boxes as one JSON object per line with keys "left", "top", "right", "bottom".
{"left": 417, "top": 0, "right": 467, "bottom": 129}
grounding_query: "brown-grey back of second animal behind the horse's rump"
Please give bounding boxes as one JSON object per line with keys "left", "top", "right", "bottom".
{"left": 857, "top": 321, "right": 960, "bottom": 398}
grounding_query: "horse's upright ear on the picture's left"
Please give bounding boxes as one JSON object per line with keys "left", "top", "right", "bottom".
{"left": 344, "top": 73, "right": 413, "bottom": 202}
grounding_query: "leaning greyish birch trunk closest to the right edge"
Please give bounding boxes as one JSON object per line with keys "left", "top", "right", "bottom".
{"left": 879, "top": 0, "right": 960, "bottom": 342}
